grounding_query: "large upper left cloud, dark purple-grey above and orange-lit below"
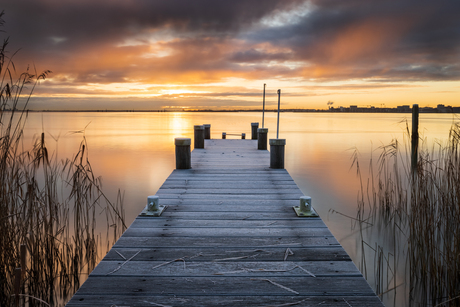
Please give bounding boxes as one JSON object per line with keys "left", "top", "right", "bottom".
{"left": 4, "top": 0, "right": 301, "bottom": 83}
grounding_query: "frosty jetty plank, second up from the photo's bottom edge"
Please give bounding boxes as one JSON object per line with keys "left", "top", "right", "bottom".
{"left": 70, "top": 275, "right": 374, "bottom": 296}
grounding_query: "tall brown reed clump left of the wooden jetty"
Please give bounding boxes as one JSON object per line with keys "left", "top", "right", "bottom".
{"left": 0, "top": 12, "right": 126, "bottom": 306}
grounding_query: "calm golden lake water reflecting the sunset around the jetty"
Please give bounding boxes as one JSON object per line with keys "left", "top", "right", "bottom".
{"left": 24, "top": 112, "right": 455, "bottom": 306}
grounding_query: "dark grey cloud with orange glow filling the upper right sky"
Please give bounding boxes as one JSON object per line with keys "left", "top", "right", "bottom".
{"left": 248, "top": 0, "right": 460, "bottom": 80}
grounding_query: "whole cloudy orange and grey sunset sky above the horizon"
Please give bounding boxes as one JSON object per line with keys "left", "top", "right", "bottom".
{"left": 0, "top": 0, "right": 460, "bottom": 110}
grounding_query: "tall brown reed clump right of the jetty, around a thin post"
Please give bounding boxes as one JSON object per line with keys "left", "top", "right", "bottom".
{"left": 354, "top": 123, "right": 460, "bottom": 306}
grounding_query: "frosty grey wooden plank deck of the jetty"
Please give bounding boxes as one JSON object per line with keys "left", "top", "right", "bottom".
{"left": 67, "top": 140, "right": 383, "bottom": 307}
